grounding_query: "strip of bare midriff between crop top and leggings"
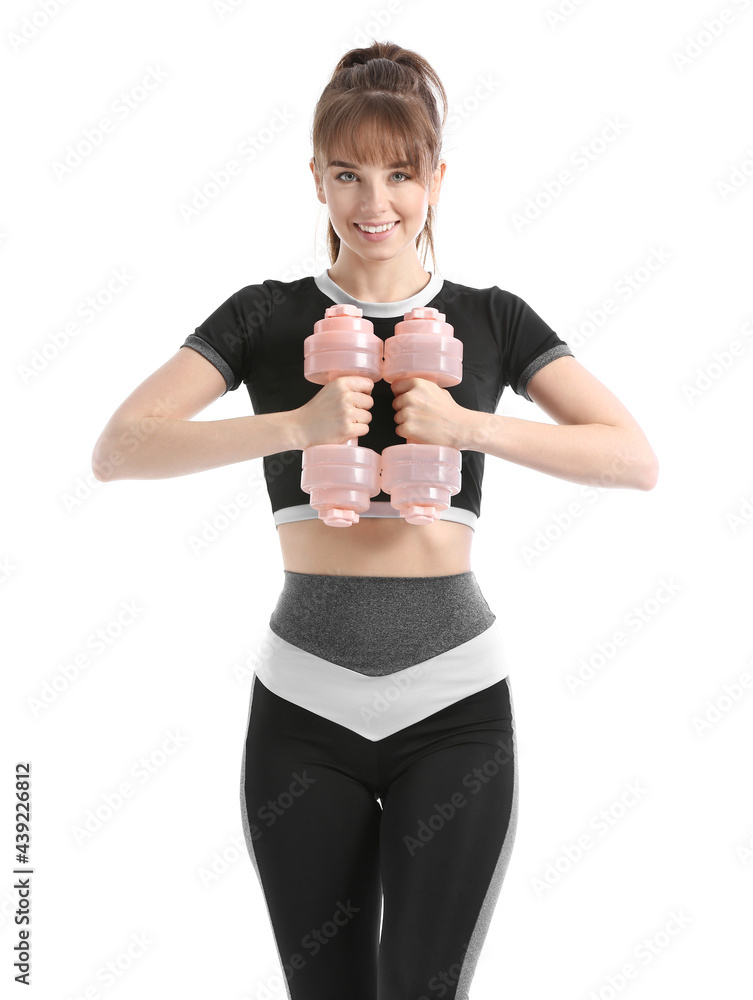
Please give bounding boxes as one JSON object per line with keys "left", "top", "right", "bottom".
{"left": 277, "top": 517, "right": 474, "bottom": 576}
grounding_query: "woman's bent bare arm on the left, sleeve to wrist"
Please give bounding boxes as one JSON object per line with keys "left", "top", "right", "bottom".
{"left": 92, "top": 347, "right": 303, "bottom": 482}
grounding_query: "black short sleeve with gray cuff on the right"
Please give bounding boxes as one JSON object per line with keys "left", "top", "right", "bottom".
{"left": 495, "top": 286, "right": 574, "bottom": 402}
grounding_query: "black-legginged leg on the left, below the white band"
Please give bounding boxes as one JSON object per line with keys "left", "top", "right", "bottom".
{"left": 241, "top": 677, "right": 381, "bottom": 1000}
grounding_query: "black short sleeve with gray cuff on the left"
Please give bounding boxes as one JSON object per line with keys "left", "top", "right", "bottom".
{"left": 180, "top": 284, "right": 273, "bottom": 396}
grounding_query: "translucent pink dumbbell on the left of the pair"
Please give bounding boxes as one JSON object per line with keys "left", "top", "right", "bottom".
{"left": 301, "top": 304, "right": 383, "bottom": 528}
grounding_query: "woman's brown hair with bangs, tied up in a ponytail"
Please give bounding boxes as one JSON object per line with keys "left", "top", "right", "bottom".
{"left": 311, "top": 42, "right": 447, "bottom": 270}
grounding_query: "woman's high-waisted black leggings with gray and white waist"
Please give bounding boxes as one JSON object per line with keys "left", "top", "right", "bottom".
{"left": 241, "top": 573, "right": 518, "bottom": 1000}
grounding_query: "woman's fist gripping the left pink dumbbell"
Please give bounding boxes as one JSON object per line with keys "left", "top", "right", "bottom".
{"left": 295, "top": 375, "right": 374, "bottom": 449}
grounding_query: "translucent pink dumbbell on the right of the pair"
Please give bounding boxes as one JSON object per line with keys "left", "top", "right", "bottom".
{"left": 382, "top": 309, "right": 463, "bottom": 524}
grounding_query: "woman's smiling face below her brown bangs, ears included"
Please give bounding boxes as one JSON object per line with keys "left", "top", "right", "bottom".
{"left": 310, "top": 146, "right": 446, "bottom": 260}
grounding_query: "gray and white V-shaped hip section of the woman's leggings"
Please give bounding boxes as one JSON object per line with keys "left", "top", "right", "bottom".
{"left": 255, "top": 570, "right": 509, "bottom": 741}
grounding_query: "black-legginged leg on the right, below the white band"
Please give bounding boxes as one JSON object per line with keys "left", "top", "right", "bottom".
{"left": 379, "top": 678, "right": 517, "bottom": 1000}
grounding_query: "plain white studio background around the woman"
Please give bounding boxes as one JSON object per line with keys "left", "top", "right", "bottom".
{"left": 0, "top": 0, "right": 753, "bottom": 1000}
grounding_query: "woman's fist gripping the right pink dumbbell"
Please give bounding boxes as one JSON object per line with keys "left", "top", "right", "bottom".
{"left": 392, "top": 378, "right": 475, "bottom": 449}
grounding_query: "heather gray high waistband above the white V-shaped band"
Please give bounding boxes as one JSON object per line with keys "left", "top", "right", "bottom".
{"left": 269, "top": 570, "right": 496, "bottom": 676}
